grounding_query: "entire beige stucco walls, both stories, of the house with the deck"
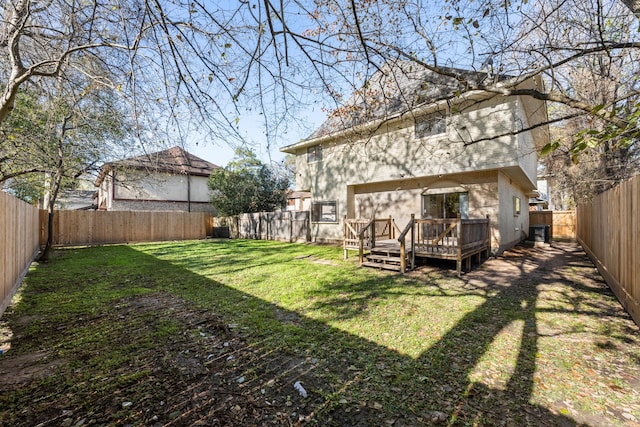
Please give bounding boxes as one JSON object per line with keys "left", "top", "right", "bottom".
{"left": 288, "top": 96, "right": 538, "bottom": 253}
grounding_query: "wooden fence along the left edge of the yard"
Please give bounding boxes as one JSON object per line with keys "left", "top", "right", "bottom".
{"left": 0, "top": 191, "right": 39, "bottom": 316}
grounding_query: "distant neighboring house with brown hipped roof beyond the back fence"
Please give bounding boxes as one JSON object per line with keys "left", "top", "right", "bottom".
{"left": 95, "top": 147, "right": 219, "bottom": 212}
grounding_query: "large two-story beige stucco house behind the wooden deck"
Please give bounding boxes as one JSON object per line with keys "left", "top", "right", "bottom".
{"left": 281, "top": 62, "right": 549, "bottom": 253}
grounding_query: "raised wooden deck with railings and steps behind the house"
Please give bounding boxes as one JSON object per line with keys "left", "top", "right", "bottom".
{"left": 344, "top": 217, "right": 491, "bottom": 275}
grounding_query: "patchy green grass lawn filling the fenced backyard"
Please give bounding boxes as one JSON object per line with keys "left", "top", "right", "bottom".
{"left": 0, "top": 240, "right": 640, "bottom": 426}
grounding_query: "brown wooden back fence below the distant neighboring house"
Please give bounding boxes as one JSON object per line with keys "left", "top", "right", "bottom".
{"left": 40, "top": 210, "right": 213, "bottom": 245}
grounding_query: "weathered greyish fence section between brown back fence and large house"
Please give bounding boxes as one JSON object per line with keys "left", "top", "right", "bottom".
{"left": 213, "top": 211, "right": 311, "bottom": 242}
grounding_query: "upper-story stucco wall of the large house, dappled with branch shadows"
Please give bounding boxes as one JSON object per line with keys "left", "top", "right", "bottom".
{"left": 296, "top": 98, "right": 536, "bottom": 197}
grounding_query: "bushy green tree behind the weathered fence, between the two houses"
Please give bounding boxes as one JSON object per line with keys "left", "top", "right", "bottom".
{"left": 209, "top": 148, "right": 289, "bottom": 215}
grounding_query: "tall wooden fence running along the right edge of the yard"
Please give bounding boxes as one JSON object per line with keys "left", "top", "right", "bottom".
{"left": 577, "top": 175, "right": 640, "bottom": 325}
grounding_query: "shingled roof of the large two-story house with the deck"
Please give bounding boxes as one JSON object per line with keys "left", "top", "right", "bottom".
{"left": 305, "top": 61, "right": 498, "bottom": 141}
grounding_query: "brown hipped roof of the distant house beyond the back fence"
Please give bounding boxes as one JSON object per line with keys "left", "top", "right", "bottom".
{"left": 95, "top": 146, "right": 220, "bottom": 187}
